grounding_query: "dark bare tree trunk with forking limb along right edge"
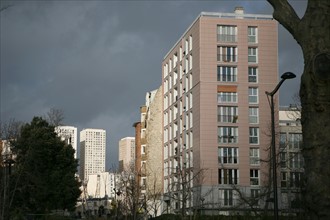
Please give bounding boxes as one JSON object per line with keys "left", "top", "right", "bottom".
{"left": 267, "top": 0, "right": 330, "bottom": 219}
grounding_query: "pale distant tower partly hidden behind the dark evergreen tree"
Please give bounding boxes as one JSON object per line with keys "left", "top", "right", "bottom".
{"left": 55, "top": 126, "right": 78, "bottom": 159}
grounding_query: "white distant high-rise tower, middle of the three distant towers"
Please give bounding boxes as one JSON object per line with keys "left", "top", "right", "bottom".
{"left": 80, "top": 128, "right": 106, "bottom": 180}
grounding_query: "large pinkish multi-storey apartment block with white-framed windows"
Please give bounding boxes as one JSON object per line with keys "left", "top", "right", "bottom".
{"left": 162, "top": 8, "right": 278, "bottom": 214}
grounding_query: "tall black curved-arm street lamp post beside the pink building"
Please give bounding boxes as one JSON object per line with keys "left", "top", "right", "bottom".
{"left": 266, "top": 72, "right": 296, "bottom": 220}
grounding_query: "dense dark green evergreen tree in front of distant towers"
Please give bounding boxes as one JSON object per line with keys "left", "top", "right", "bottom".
{"left": 11, "top": 117, "right": 80, "bottom": 214}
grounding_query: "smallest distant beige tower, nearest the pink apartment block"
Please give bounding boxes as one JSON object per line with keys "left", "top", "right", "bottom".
{"left": 118, "top": 137, "right": 135, "bottom": 172}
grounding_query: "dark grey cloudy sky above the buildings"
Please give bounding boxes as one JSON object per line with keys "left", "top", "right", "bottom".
{"left": 0, "top": 0, "right": 306, "bottom": 168}
